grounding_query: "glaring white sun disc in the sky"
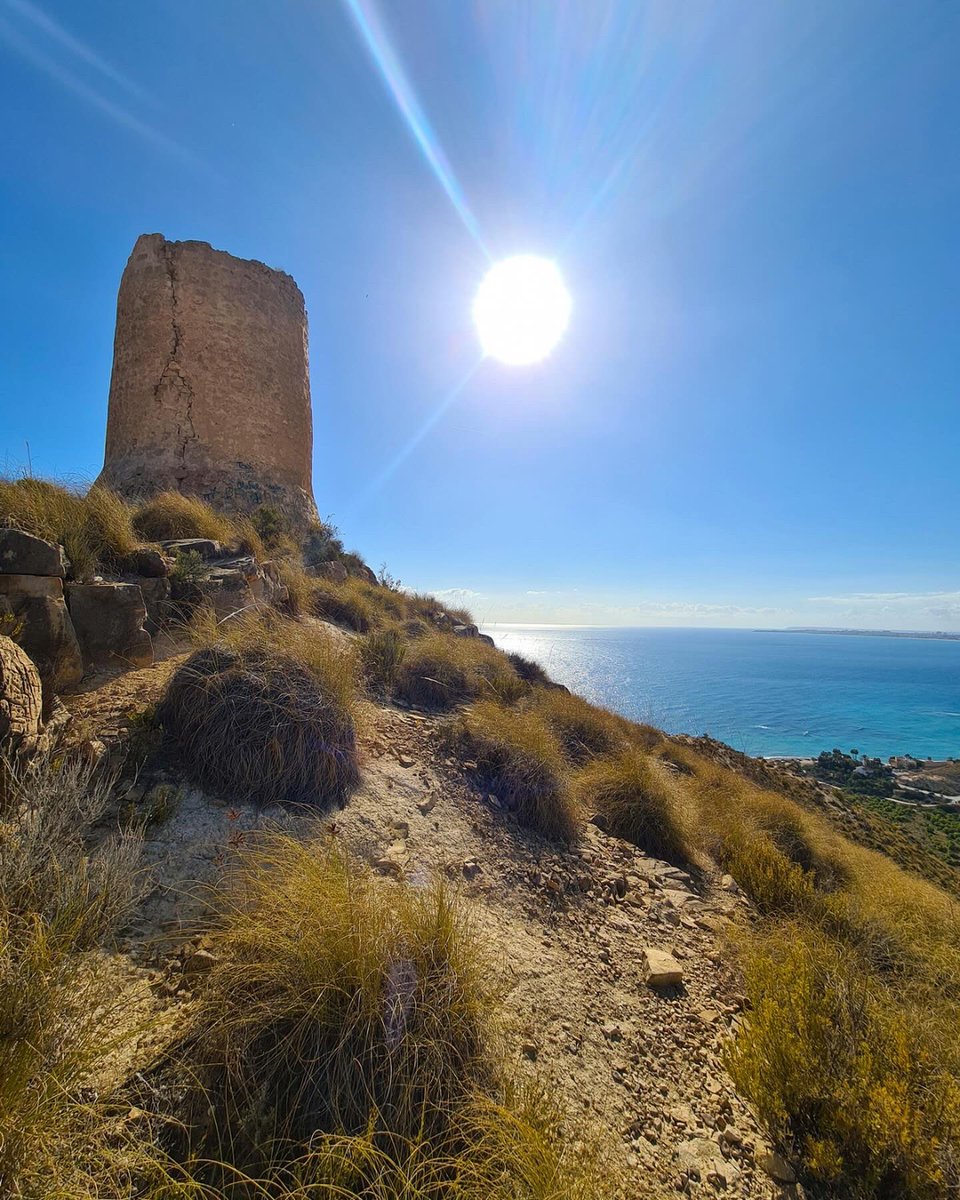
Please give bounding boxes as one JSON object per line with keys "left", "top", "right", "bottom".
{"left": 473, "top": 254, "right": 572, "bottom": 367}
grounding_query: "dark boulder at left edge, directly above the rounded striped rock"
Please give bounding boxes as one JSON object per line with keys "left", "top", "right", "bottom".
{"left": 0, "top": 575, "right": 83, "bottom": 702}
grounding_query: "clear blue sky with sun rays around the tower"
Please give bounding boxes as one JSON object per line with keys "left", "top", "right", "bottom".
{"left": 0, "top": 0, "right": 960, "bottom": 630}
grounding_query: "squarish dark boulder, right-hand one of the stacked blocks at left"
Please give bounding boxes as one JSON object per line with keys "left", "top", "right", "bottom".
{"left": 67, "top": 583, "right": 154, "bottom": 667}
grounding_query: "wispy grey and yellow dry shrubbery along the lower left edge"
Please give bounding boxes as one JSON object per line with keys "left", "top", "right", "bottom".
{"left": 0, "top": 755, "right": 159, "bottom": 1200}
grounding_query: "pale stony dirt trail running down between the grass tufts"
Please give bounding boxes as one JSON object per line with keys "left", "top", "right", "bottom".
{"left": 68, "top": 672, "right": 799, "bottom": 1198}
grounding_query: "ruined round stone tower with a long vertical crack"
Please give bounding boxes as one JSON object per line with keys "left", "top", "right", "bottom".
{"left": 97, "top": 233, "right": 317, "bottom": 527}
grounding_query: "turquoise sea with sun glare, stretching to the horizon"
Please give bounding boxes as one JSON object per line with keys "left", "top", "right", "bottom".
{"left": 486, "top": 625, "right": 960, "bottom": 758}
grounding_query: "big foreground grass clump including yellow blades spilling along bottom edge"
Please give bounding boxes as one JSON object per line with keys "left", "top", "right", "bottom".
{"left": 164, "top": 836, "right": 600, "bottom": 1200}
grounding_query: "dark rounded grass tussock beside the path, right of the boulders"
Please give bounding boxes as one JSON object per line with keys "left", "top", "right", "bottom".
{"left": 157, "top": 646, "right": 359, "bottom": 805}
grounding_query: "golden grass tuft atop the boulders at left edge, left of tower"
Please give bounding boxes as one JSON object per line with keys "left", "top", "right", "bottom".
{"left": 0, "top": 479, "right": 137, "bottom": 578}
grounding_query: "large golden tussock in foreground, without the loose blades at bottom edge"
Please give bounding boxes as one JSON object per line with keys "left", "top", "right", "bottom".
{"left": 176, "top": 836, "right": 493, "bottom": 1168}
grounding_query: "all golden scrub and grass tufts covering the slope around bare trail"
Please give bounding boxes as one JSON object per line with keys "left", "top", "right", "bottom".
{"left": 0, "top": 479, "right": 960, "bottom": 1200}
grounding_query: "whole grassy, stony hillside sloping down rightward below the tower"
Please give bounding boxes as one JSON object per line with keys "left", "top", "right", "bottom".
{"left": 0, "top": 481, "right": 960, "bottom": 1200}
